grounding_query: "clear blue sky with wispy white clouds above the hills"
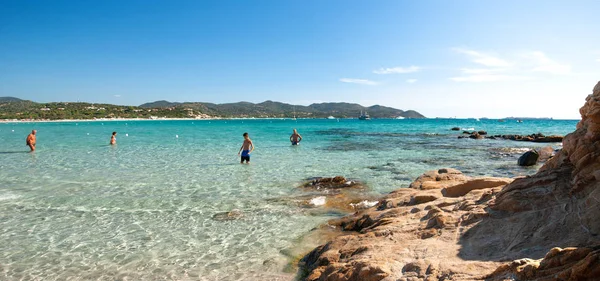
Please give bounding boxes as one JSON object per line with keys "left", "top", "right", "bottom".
{"left": 0, "top": 0, "right": 600, "bottom": 119}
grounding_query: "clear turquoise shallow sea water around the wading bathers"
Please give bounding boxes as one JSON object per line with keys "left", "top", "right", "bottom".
{"left": 0, "top": 119, "right": 577, "bottom": 280}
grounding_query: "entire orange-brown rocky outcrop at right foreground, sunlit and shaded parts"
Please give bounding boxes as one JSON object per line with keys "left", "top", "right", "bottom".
{"left": 301, "top": 83, "right": 600, "bottom": 281}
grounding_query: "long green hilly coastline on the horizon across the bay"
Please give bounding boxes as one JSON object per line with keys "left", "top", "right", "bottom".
{"left": 0, "top": 97, "right": 424, "bottom": 120}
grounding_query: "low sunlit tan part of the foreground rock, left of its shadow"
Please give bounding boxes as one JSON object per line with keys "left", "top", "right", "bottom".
{"left": 301, "top": 168, "right": 512, "bottom": 281}
